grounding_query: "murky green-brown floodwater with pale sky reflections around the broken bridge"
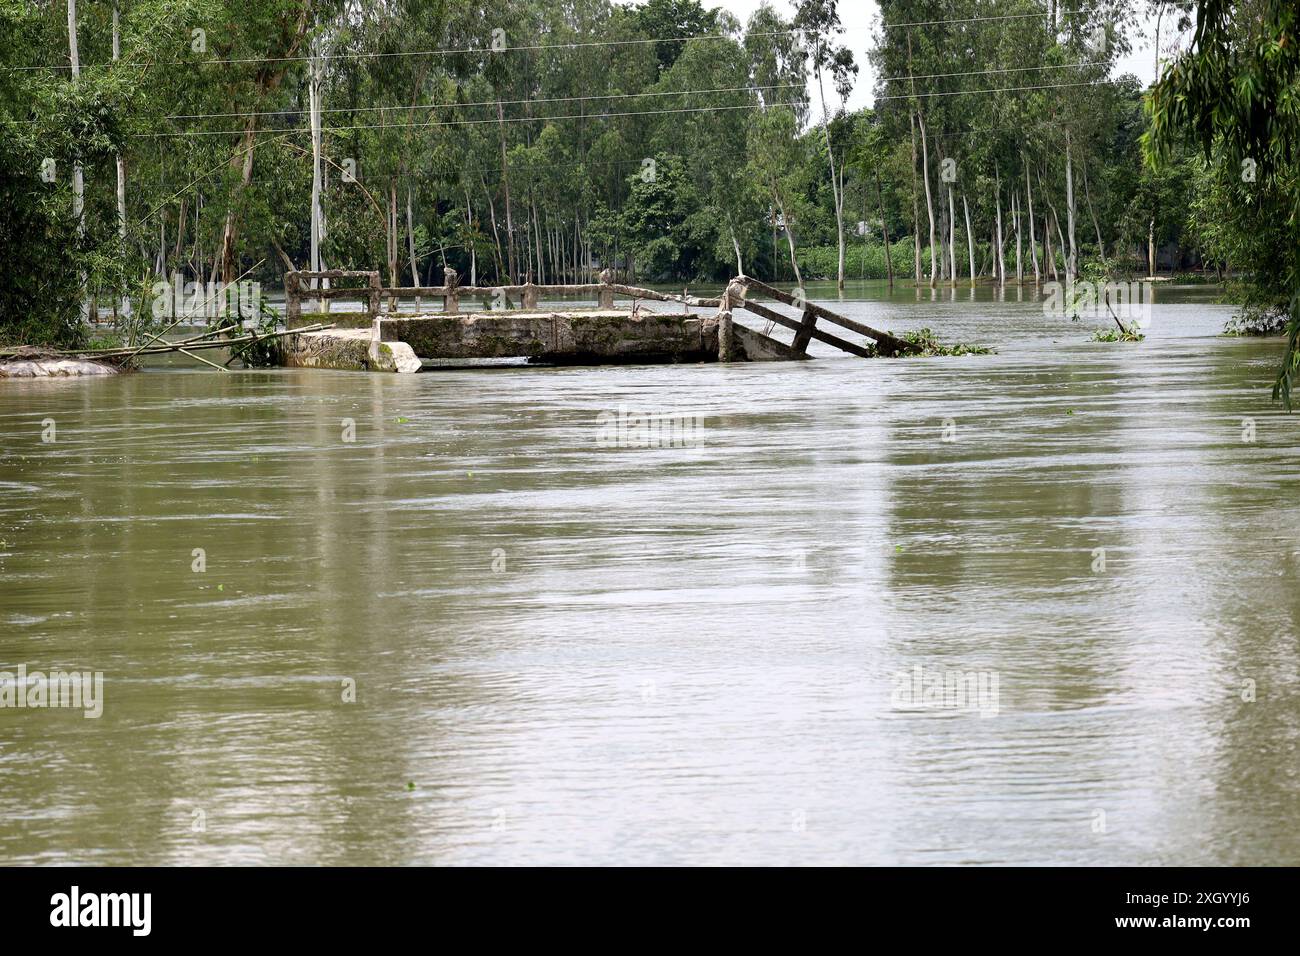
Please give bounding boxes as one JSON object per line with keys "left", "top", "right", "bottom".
{"left": 0, "top": 287, "right": 1300, "bottom": 864}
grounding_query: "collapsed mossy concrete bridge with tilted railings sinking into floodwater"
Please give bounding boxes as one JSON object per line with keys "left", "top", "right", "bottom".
{"left": 282, "top": 269, "right": 919, "bottom": 372}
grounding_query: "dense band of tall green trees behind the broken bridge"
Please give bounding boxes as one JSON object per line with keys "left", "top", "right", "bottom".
{"left": 0, "top": 0, "right": 1284, "bottom": 356}
